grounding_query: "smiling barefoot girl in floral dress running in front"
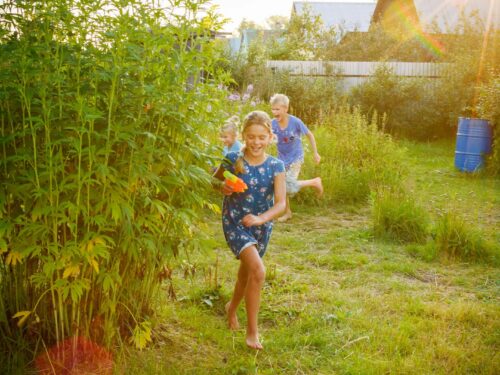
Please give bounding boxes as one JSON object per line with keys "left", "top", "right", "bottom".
{"left": 214, "top": 111, "right": 286, "bottom": 349}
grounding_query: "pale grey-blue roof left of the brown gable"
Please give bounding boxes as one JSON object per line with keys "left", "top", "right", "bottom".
{"left": 292, "top": 1, "right": 376, "bottom": 32}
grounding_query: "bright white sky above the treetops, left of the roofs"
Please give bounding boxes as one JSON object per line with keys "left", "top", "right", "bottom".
{"left": 207, "top": 0, "right": 375, "bottom": 32}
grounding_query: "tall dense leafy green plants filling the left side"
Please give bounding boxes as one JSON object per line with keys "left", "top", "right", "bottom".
{"left": 0, "top": 0, "right": 227, "bottom": 373}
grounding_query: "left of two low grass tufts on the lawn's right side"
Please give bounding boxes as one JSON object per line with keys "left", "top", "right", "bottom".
{"left": 372, "top": 190, "right": 429, "bottom": 243}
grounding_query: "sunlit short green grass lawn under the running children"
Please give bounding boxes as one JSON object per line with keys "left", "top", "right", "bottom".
{"left": 116, "top": 143, "right": 500, "bottom": 374}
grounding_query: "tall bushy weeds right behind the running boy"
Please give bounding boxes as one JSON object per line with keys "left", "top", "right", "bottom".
{"left": 299, "top": 106, "right": 407, "bottom": 204}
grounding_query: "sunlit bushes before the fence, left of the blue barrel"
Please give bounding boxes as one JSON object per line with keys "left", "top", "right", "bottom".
{"left": 350, "top": 56, "right": 494, "bottom": 140}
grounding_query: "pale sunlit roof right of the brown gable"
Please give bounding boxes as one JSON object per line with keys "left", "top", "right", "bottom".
{"left": 413, "top": 0, "right": 500, "bottom": 33}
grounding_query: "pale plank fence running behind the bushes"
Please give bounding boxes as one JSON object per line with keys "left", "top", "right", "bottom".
{"left": 266, "top": 60, "right": 447, "bottom": 89}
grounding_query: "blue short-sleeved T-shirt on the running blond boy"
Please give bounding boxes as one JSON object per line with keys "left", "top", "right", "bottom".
{"left": 272, "top": 115, "right": 309, "bottom": 168}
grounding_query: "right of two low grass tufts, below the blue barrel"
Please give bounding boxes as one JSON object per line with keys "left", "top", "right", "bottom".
{"left": 435, "top": 212, "right": 493, "bottom": 261}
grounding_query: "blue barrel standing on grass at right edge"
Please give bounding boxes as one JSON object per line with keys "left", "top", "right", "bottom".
{"left": 455, "top": 117, "right": 492, "bottom": 172}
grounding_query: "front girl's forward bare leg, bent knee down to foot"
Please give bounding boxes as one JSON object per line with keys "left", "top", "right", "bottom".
{"left": 240, "top": 246, "right": 266, "bottom": 350}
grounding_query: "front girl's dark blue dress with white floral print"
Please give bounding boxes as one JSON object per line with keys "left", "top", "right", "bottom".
{"left": 222, "top": 152, "right": 285, "bottom": 259}
